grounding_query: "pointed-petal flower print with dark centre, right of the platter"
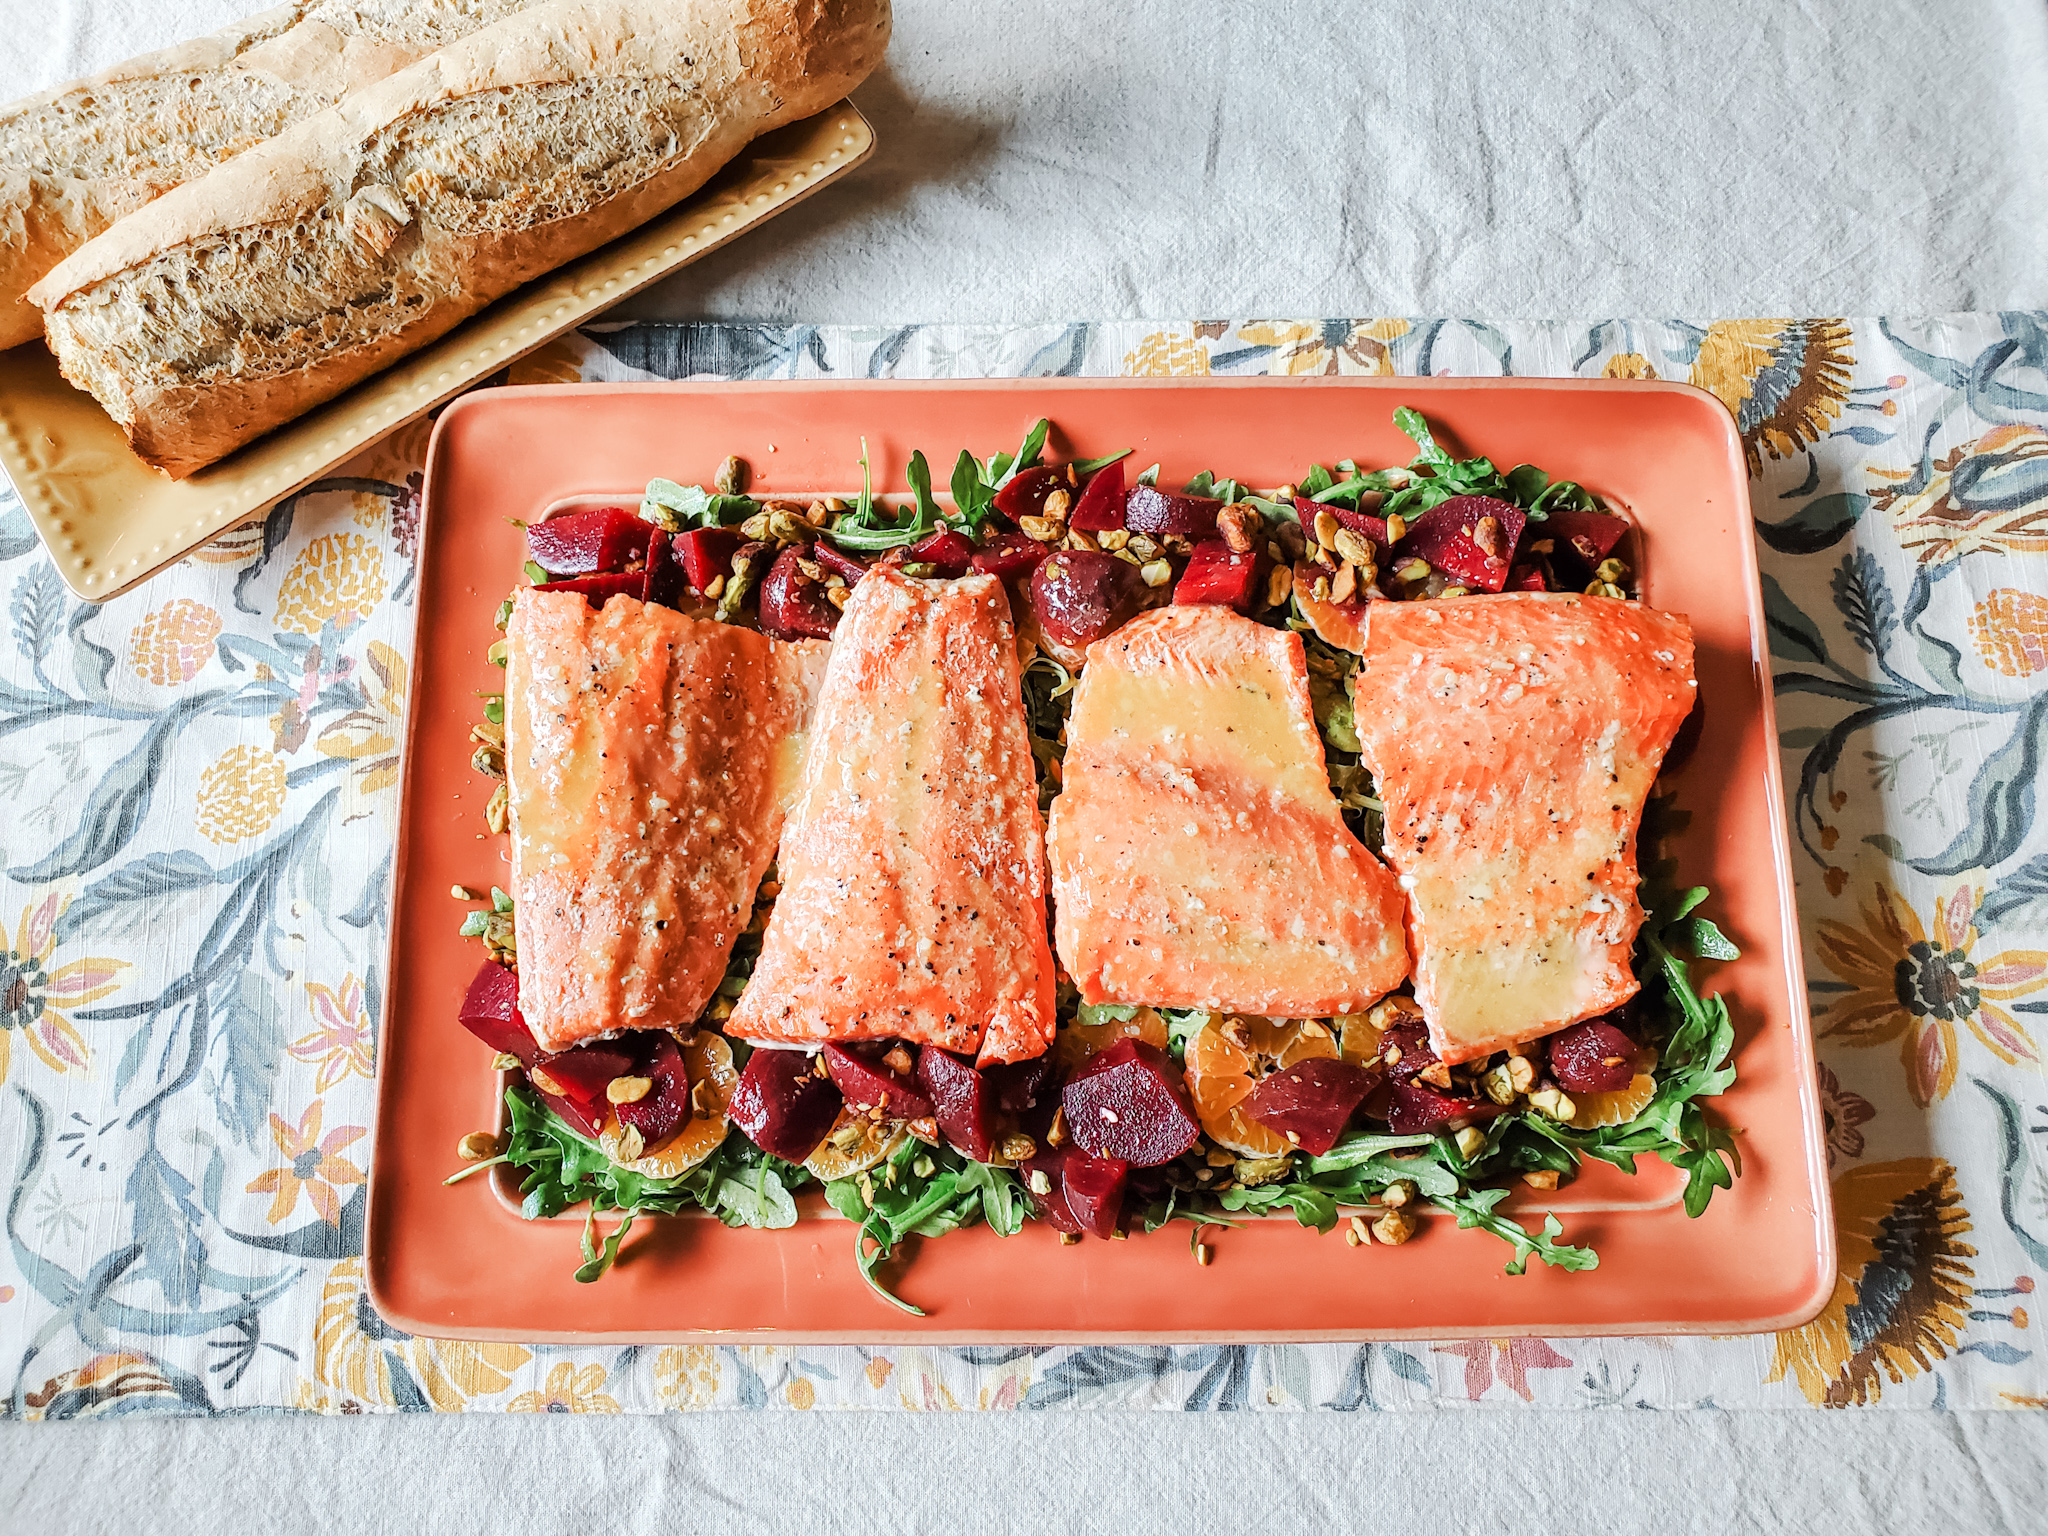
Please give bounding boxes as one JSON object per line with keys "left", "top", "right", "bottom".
{"left": 1817, "top": 881, "right": 2048, "bottom": 1108}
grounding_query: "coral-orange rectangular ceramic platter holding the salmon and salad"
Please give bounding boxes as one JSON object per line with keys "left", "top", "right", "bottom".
{"left": 369, "top": 379, "right": 1835, "bottom": 1341}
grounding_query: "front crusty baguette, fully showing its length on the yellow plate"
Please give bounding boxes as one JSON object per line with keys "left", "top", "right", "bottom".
{"left": 31, "top": 0, "right": 889, "bottom": 479}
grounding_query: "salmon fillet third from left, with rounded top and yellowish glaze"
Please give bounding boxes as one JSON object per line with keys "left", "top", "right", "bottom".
{"left": 1049, "top": 606, "right": 1409, "bottom": 1018}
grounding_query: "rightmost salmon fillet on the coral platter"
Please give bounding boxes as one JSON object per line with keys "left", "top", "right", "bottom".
{"left": 1356, "top": 592, "right": 1696, "bottom": 1063}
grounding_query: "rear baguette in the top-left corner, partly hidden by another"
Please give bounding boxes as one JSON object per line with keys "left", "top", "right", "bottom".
{"left": 0, "top": 0, "right": 539, "bottom": 348}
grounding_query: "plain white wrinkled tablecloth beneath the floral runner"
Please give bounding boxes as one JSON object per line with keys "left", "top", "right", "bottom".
{"left": 0, "top": 0, "right": 2048, "bottom": 1532}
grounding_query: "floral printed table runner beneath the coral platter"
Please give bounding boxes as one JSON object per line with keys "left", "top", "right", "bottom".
{"left": 0, "top": 313, "right": 2048, "bottom": 1419}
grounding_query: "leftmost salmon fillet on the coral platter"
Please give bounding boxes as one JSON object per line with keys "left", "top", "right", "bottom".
{"left": 506, "top": 590, "right": 829, "bottom": 1051}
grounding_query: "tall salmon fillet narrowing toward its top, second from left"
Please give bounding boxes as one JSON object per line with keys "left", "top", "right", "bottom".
{"left": 725, "top": 565, "right": 1053, "bottom": 1063}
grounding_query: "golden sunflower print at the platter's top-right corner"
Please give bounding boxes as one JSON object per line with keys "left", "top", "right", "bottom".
{"left": 1692, "top": 319, "right": 1855, "bottom": 475}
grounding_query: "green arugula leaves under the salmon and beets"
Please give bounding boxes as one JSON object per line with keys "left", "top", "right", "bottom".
{"left": 479, "top": 408, "right": 1741, "bottom": 1313}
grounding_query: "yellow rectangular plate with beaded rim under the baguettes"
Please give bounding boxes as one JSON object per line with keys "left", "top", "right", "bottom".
{"left": 0, "top": 100, "right": 874, "bottom": 602}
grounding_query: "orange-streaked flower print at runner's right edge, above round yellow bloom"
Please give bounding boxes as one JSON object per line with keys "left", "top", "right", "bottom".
{"left": 1870, "top": 424, "right": 2048, "bottom": 565}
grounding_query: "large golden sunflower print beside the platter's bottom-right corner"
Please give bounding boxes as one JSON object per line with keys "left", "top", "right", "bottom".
{"left": 1763, "top": 1157, "right": 1976, "bottom": 1407}
